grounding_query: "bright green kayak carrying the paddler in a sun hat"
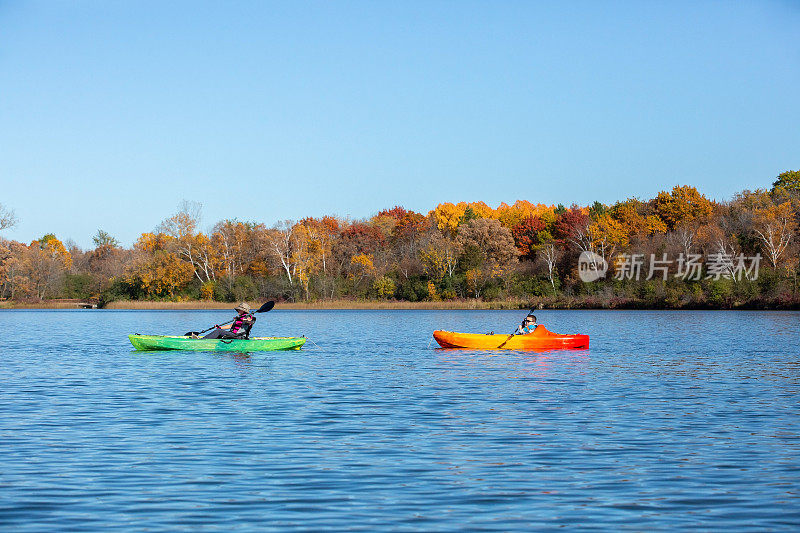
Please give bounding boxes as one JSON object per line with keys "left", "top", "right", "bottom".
{"left": 128, "top": 335, "right": 306, "bottom": 352}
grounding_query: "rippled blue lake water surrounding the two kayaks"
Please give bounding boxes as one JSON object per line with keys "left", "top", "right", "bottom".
{"left": 0, "top": 309, "right": 800, "bottom": 531}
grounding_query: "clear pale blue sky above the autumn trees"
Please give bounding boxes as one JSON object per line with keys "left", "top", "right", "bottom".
{"left": 0, "top": 0, "right": 800, "bottom": 247}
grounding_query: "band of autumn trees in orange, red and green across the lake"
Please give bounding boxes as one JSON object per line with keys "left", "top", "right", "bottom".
{"left": 0, "top": 171, "right": 800, "bottom": 308}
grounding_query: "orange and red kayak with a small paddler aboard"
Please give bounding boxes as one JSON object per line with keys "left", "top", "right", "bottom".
{"left": 433, "top": 325, "right": 589, "bottom": 350}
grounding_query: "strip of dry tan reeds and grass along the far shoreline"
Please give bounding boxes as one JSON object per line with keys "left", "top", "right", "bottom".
{"left": 0, "top": 299, "right": 800, "bottom": 311}
